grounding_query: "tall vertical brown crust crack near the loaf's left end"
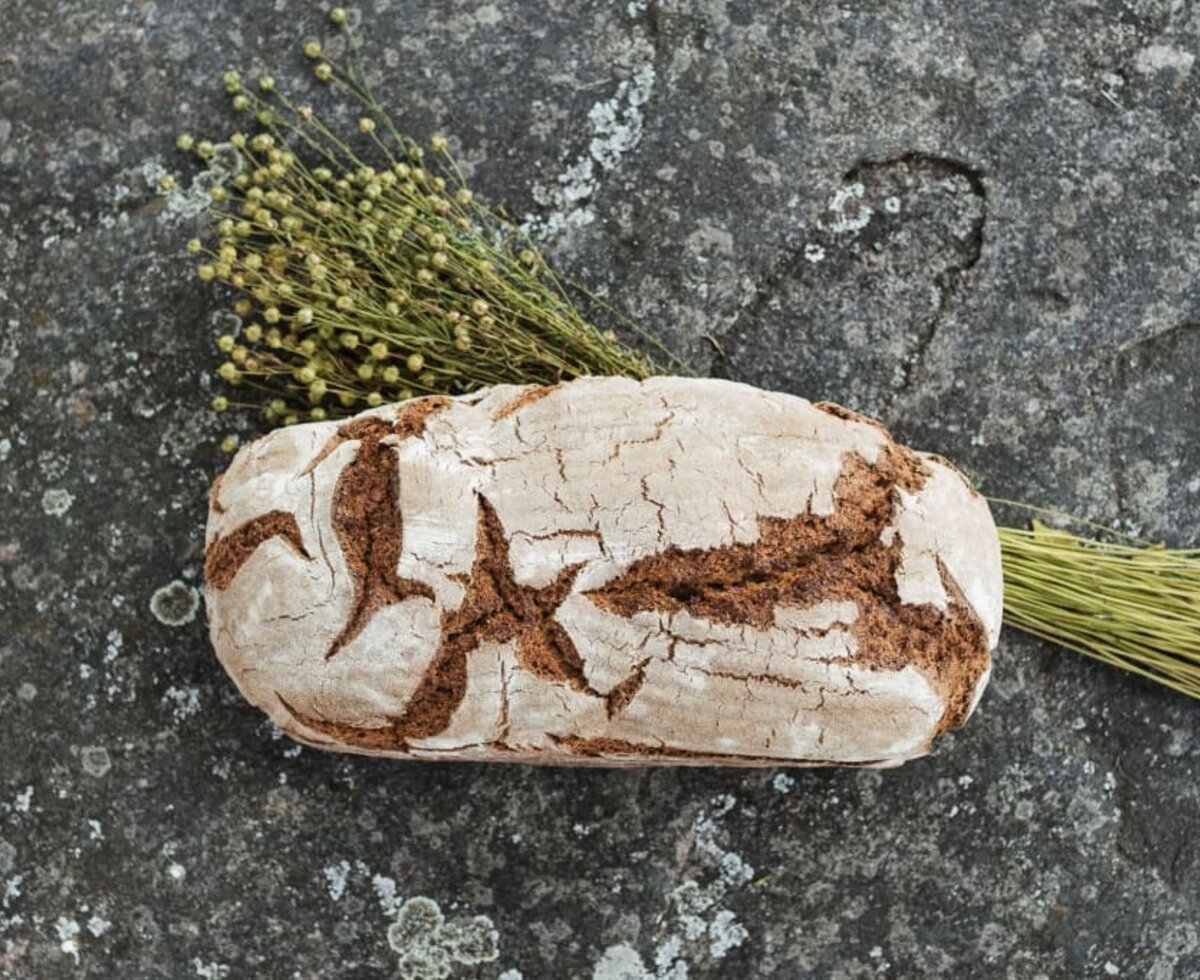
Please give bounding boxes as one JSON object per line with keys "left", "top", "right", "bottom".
{"left": 325, "top": 417, "right": 433, "bottom": 660}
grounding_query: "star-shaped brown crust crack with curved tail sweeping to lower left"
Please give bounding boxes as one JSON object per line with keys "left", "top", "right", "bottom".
{"left": 280, "top": 494, "right": 600, "bottom": 750}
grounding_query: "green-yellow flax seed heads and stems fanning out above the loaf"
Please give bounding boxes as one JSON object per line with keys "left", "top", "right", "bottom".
{"left": 178, "top": 10, "right": 654, "bottom": 423}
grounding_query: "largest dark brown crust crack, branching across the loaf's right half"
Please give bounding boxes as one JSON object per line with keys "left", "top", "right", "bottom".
{"left": 587, "top": 446, "right": 990, "bottom": 733}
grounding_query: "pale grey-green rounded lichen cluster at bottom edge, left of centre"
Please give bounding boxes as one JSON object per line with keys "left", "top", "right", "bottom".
{"left": 388, "top": 895, "right": 499, "bottom": 980}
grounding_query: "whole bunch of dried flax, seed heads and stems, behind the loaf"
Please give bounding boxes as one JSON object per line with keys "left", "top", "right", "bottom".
{"left": 174, "top": 8, "right": 1200, "bottom": 697}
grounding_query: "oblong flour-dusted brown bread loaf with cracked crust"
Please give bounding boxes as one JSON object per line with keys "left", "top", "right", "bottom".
{"left": 205, "top": 378, "right": 1002, "bottom": 765}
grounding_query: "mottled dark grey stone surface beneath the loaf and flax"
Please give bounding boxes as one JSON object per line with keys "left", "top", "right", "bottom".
{"left": 0, "top": 0, "right": 1200, "bottom": 980}
